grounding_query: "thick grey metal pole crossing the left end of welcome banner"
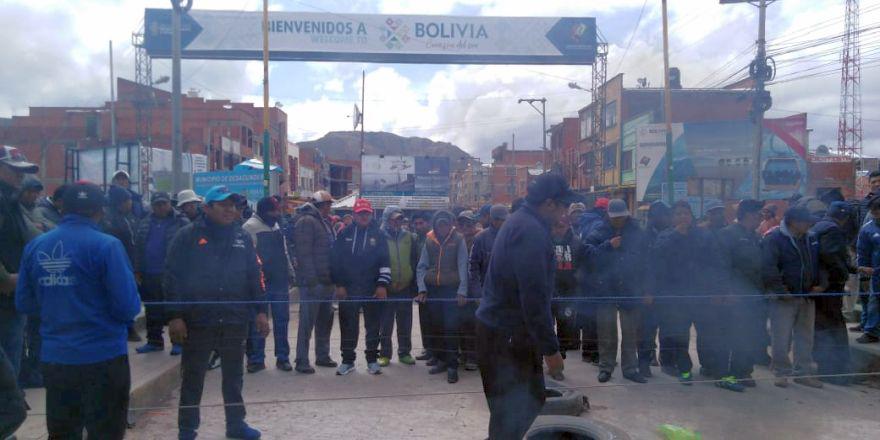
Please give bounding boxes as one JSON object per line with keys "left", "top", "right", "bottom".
{"left": 171, "top": 0, "right": 192, "bottom": 194}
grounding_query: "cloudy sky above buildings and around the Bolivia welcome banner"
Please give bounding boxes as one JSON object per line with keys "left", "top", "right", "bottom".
{"left": 0, "top": 0, "right": 880, "bottom": 160}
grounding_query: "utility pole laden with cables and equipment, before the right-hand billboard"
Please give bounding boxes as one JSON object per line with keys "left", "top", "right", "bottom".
{"left": 720, "top": 0, "right": 776, "bottom": 200}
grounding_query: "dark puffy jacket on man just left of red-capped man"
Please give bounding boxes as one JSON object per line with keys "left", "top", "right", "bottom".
{"left": 293, "top": 203, "right": 336, "bottom": 287}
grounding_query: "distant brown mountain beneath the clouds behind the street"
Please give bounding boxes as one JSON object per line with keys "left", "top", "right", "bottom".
{"left": 297, "top": 131, "right": 471, "bottom": 169}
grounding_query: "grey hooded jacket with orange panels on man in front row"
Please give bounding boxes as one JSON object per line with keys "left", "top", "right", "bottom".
{"left": 416, "top": 211, "right": 468, "bottom": 296}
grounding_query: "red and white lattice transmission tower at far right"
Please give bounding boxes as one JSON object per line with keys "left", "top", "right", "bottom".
{"left": 837, "top": 0, "right": 862, "bottom": 158}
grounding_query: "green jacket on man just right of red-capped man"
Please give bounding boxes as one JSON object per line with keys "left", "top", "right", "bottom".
{"left": 382, "top": 205, "right": 420, "bottom": 295}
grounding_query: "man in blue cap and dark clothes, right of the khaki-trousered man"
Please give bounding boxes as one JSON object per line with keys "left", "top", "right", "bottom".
{"left": 811, "top": 201, "right": 856, "bottom": 385}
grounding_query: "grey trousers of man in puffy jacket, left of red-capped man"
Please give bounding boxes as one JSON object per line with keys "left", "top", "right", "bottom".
{"left": 296, "top": 285, "right": 333, "bottom": 365}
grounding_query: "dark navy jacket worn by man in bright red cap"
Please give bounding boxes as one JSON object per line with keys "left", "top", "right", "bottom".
{"left": 330, "top": 220, "right": 391, "bottom": 298}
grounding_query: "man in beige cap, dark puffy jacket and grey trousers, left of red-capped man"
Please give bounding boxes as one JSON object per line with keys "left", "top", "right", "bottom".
{"left": 293, "top": 191, "right": 337, "bottom": 374}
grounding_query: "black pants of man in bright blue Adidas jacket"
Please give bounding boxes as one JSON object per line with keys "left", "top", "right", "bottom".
{"left": 42, "top": 355, "right": 131, "bottom": 440}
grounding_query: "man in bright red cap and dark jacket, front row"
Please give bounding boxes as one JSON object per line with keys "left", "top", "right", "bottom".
{"left": 330, "top": 199, "right": 391, "bottom": 376}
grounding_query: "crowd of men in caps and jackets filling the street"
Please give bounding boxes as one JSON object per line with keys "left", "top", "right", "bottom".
{"left": 0, "top": 142, "right": 880, "bottom": 439}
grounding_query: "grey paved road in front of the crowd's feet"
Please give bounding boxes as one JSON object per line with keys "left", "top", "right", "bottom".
{"left": 129, "top": 310, "right": 880, "bottom": 440}
